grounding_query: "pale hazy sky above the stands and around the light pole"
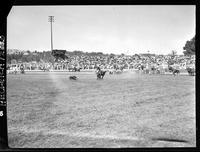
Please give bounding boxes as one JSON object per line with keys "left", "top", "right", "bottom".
{"left": 7, "top": 5, "right": 196, "bottom": 54}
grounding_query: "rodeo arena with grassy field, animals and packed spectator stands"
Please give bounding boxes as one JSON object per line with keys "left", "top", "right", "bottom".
{"left": 7, "top": 50, "right": 196, "bottom": 148}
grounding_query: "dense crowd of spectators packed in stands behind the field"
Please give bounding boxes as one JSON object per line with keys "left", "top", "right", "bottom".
{"left": 8, "top": 54, "right": 195, "bottom": 70}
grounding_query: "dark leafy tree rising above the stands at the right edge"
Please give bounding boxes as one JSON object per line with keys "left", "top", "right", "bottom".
{"left": 183, "top": 36, "right": 195, "bottom": 56}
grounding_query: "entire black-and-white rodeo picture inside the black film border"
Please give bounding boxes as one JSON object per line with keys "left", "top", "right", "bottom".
{"left": 6, "top": 5, "right": 197, "bottom": 148}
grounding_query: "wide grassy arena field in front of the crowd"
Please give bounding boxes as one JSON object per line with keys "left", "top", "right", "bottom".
{"left": 7, "top": 72, "right": 196, "bottom": 148}
